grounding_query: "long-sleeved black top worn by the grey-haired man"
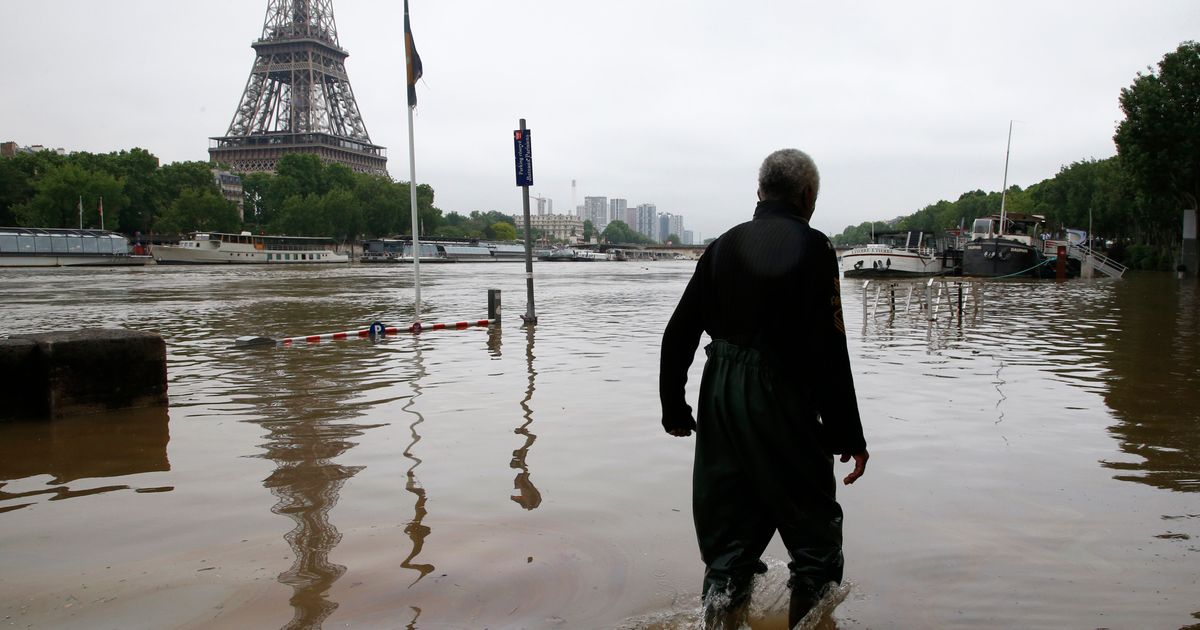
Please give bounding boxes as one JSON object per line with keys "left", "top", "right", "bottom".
{"left": 659, "top": 202, "right": 866, "bottom": 454}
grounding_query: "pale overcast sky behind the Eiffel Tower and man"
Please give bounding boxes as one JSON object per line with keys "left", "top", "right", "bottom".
{"left": 0, "top": 0, "right": 1200, "bottom": 238}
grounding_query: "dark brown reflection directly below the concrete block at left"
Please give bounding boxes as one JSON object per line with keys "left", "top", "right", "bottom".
{"left": 0, "top": 407, "right": 173, "bottom": 512}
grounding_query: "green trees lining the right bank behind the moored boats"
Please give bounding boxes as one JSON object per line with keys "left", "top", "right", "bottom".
{"left": 833, "top": 42, "right": 1200, "bottom": 270}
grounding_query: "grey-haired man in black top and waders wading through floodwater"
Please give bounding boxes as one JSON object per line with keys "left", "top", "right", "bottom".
{"left": 659, "top": 149, "right": 868, "bottom": 628}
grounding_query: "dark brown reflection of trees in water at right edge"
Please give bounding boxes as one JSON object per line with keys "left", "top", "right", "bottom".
{"left": 1105, "top": 274, "right": 1200, "bottom": 492}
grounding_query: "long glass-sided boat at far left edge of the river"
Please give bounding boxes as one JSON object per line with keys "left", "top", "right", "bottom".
{"left": 0, "top": 228, "right": 154, "bottom": 266}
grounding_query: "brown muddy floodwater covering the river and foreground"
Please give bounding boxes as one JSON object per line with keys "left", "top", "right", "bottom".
{"left": 0, "top": 263, "right": 1200, "bottom": 629}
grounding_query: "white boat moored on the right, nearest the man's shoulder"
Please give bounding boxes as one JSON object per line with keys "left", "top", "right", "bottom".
{"left": 841, "top": 232, "right": 953, "bottom": 277}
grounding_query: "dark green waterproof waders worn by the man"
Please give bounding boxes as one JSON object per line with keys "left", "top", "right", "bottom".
{"left": 692, "top": 340, "right": 842, "bottom": 610}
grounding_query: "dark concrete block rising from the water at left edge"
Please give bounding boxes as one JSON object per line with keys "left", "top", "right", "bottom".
{"left": 11, "top": 329, "right": 167, "bottom": 418}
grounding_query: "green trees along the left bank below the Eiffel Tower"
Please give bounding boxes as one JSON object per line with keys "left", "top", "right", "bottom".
{"left": 0, "top": 149, "right": 672, "bottom": 242}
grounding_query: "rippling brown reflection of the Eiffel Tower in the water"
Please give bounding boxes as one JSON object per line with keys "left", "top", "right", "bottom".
{"left": 245, "top": 348, "right": 378, "bottom": 629}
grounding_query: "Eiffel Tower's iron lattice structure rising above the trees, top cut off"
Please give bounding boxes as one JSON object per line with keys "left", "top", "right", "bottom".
{"left": 209, "top": 0, "right": 388, "bottom": 175}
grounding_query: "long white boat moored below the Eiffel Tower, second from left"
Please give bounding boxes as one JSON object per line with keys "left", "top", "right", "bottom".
{"left": 151, "top": 232, "right": 350, "bottom": 265}
